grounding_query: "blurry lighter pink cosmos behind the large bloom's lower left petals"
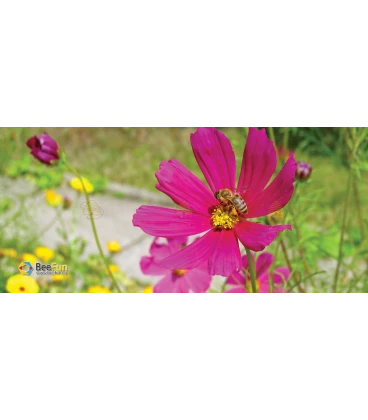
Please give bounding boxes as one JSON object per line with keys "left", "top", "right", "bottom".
{"left": 140, "top": 236, "right": 212, "bottom": 294}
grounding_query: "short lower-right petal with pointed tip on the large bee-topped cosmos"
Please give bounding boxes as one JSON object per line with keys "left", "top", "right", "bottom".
{"left": 235, "top": 221, "right": 291, "bottom": 251}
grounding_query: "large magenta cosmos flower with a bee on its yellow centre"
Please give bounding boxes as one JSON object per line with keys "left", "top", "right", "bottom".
{"left": 133, "top": 127, "right": 296, "bottom": 276}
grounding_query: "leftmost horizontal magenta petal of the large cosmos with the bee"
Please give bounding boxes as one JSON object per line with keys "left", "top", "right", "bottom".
{"left": 133, "top": 206, "right": 212, "bottom": 238}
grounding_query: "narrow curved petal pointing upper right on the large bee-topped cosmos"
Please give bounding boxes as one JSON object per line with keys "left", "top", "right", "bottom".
{"left": 247, "top": 155, "right": 296, "bottom": 218}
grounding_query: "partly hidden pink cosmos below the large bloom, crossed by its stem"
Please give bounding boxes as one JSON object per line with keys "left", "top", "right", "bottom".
{"left": 224, "top": 252, "right": 290, "bottom": 295}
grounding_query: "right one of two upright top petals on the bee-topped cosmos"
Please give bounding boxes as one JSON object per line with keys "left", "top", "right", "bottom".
{"left": 237, "top": 127, "right": 277, "bottom": 203}
